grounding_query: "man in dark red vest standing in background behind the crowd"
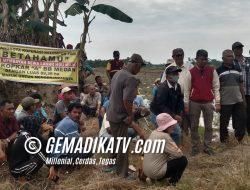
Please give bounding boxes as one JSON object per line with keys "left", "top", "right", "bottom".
{"left": 106, "top": 51, "right": 124, "bottom": 81}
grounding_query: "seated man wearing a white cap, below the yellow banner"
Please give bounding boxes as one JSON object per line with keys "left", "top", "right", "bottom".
{"left": 53, "top": 87, "right": 76, "bottom": 125}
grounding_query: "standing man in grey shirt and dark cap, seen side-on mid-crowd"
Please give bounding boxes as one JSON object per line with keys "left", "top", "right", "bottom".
{"left": 107, "top": 54, "right": 143, "bottom": 177}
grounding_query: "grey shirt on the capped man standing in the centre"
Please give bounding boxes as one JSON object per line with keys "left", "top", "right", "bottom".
{"left": 107, "top": 69, "right": 138, "bottom": 123}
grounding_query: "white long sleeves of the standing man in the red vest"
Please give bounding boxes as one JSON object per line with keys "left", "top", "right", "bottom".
{"left": 184, "top": 66, "right": 220, "bottom": 105}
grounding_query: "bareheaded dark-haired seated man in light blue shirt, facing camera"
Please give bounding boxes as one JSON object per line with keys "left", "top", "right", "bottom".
{"left": 51, "top": 102, "right": 92, "bottom": 158}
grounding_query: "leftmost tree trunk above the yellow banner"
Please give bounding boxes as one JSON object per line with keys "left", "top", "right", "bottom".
{"left": 2, "top": 0, "right": 9, "bottom": 41}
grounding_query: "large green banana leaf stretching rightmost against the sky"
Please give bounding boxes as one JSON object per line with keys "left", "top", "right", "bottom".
{"left": 92, "top": 4, "right": 133, "bottom": 23}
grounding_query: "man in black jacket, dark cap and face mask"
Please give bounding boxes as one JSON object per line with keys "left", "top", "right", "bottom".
{"left": 150, "top": 65, "right": 184, "bottom": 145}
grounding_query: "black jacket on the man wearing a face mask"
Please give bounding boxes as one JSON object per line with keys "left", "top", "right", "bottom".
{"left": 150, "top": 80, "right": 184, "bottom": 117}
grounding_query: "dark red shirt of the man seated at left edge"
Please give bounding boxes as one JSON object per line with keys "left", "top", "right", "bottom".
{"left": 0, "top": 114, "right": 19, "bottom": 139}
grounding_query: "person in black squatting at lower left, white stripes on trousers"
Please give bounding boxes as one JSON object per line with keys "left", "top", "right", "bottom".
{"left": 8, "top": 116, "right": 58, "bottom": 182}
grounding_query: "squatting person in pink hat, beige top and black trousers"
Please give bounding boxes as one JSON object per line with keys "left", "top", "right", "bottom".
{"left": 143, "top": 113, "right": 188, "bottom": 185}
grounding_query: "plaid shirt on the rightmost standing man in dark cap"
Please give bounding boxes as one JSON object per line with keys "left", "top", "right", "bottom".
{"left": 234, "top": 57, "right": 250, "bottom": 95}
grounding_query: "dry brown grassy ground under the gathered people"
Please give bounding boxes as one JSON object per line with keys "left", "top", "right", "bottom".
{"left": 0, "top": 69, "right": 250, "bottom": 190}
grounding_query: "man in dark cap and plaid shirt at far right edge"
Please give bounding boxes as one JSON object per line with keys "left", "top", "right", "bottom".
{"left": 232, "top": 42, "right": 250, "bottom": 135}
